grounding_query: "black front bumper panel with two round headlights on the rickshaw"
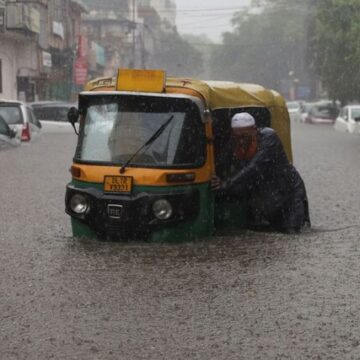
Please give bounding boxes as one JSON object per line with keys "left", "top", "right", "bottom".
{"left": 65, "top": 184, "right": 200, "bottom": 240}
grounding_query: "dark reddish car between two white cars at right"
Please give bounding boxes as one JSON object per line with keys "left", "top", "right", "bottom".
{"left": 302, "top": 102, "right": 340, "bottom": 125}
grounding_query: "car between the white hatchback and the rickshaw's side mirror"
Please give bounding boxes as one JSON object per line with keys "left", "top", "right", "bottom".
{"left": 30, "top": 101, "right": 77, "bottom": 132}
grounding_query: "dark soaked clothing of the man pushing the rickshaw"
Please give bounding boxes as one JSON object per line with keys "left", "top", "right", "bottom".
{"left": 218, "top": 128, "right": 310, "bottom": 228}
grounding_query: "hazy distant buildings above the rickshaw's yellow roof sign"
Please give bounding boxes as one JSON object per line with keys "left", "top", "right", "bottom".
{"left": 82, "top": 0, "right": 176, "bottom": 78}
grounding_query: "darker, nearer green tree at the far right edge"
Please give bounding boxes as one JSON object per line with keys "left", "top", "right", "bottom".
{"left": 313, "top": 0, "right": 360, "bottom": 104}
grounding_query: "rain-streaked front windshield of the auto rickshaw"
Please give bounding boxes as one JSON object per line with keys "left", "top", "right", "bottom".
{"left": 75, "top": 95, "right": 206, "bottom": 168}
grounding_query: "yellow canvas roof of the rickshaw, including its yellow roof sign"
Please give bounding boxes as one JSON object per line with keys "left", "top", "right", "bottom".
{"left": 85, "top": 69, "right": 292, "bottom": 161}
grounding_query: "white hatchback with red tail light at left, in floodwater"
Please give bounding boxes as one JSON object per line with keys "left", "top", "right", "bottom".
{"left": 0, "top": 100, "right": 41, "bottom": 141}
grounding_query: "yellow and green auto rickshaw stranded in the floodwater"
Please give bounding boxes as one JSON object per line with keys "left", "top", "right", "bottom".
{"left": 65, "top": 69, "right": 292, "bottom": 241}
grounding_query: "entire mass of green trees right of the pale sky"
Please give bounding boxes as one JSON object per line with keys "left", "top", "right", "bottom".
{"left": 211, "top": 0, "right": 360, "bottom": 103}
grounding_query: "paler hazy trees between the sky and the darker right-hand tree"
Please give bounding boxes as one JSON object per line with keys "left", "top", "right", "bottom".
{"left": 211, "top": 0, "right": 308, "bottom": 93}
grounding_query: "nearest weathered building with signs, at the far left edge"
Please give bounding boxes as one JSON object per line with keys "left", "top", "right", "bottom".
{"left": 0, "top": 0, "right": 86, "bottom": 102}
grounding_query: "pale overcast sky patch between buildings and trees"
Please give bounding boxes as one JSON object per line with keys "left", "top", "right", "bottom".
{"left": 175, "top": 0, "right": 250, "bottom": 42}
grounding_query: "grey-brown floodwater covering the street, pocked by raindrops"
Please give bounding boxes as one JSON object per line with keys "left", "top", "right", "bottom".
{"left": 0, "top": 124, "right": 360, "bottom": 360}
